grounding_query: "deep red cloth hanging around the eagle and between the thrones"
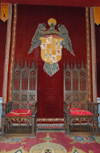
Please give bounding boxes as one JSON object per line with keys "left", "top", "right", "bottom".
{"left": 11, "top": 5, "right": 86, "bottom": 118}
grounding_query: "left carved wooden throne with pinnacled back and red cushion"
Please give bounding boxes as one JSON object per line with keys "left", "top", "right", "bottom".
{"left": 2, "top": 62, "right": 37, "bottom": 137}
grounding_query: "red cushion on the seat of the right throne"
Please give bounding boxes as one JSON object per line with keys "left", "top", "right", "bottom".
{"left": 70, "top": 108, "right": 93, "bottom": 115}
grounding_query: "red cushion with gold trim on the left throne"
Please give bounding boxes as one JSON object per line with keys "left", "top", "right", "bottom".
{"left": 7, "top": 109, "right": 32, "bottom": 116}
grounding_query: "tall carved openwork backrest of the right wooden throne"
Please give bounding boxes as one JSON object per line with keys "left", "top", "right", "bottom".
{"left": 64, "top": 62, "right": 88, "bottom": 103}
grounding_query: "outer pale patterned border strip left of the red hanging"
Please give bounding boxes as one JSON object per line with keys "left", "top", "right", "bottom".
{"left": 2, "top": 4, "right": 12, "bottom": 103}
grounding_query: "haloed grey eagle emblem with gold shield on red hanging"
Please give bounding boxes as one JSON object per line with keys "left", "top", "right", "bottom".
{"left": 28, "top": 18, "right": 74, "bottom": 76}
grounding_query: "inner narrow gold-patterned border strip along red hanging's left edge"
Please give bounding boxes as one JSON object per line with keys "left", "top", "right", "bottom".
{"left": 8, "top": 4, "right": 17, "bottom": 101}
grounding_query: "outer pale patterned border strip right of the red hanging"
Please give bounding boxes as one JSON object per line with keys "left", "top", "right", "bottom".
{"left": 90, "top": 7, "right": 97, "bottom": 102}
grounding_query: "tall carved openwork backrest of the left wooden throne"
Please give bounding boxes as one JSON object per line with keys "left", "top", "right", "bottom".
{"left": 12, "top": 62, "right": 37, "bottom": 104}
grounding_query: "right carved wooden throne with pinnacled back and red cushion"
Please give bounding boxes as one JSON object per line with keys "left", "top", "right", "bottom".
{"left": 64, "top": 63, "right": 98, "bottom": 135}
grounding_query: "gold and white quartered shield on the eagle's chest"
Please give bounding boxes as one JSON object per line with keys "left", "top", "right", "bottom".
{"left": 40, "top": 35, "right": 63, "bottom": 64}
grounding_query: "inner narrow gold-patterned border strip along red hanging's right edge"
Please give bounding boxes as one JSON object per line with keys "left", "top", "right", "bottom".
{"left": 86, "top": 7, "right": 91, "bottom": 101}
